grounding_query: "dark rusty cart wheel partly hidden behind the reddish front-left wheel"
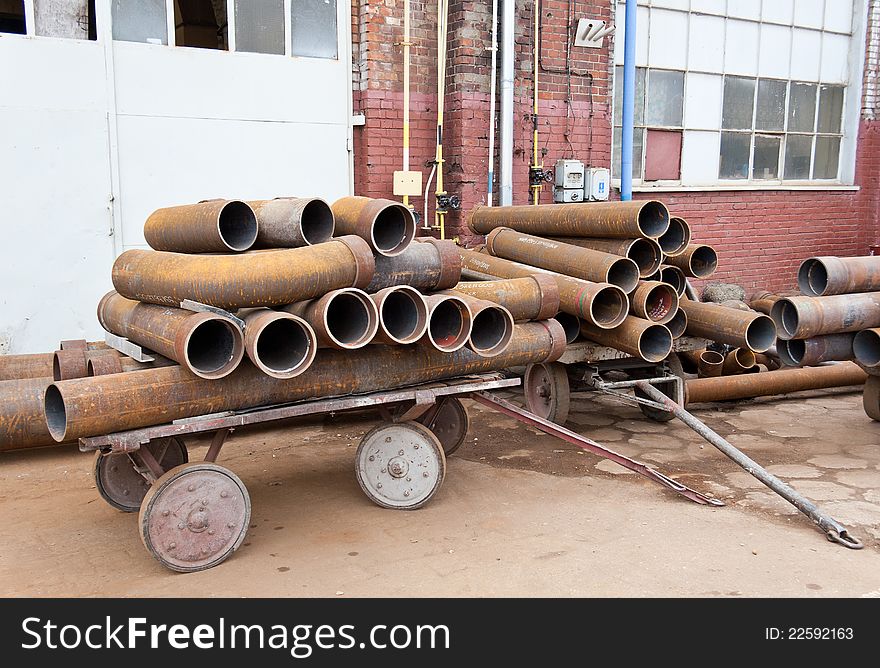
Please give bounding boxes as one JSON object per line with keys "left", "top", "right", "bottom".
{"left": 95, "top": 436, "right": 189, "bottom": 513}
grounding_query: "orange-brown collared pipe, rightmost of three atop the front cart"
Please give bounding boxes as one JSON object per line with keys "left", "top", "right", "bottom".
{"left": 331, "top": 197, "right": 416, "bottom": 256}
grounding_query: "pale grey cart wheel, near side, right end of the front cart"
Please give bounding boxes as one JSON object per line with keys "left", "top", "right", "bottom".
{"left": 355, "top": 422, "right": 446, "bottom": 510}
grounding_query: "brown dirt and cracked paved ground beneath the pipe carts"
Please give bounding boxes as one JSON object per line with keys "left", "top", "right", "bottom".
{"left": 0, "top": 384, "right": 880, "bottom": 597}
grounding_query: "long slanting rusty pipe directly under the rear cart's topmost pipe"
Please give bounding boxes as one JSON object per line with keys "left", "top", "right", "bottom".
{"left": 486, "top": 227, "right": 639, "bottom": 293}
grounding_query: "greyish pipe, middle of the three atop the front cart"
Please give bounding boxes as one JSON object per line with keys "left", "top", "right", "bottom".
{"left": 248, "top": 197, "right": 336, "bottom": 248}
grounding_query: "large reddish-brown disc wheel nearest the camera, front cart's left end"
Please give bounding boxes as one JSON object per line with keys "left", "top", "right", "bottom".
{"left": 138, "top": 462, "right": 251, "bottom": 573}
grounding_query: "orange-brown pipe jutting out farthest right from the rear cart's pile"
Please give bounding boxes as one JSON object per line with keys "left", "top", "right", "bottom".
{"left": 679, "top": 299, "right": 776, "bottom": 353}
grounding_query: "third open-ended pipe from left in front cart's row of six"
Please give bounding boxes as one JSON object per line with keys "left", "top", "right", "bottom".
{"left": 282, "top": 288, "right": 379, "bottom": 350}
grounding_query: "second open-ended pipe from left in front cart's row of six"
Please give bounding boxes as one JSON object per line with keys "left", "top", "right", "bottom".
{"left": 238, "top": 308, "right": 318, "bottom": 378}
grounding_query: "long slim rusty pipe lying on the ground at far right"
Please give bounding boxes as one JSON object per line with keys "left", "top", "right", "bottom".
{"left": 685, "top": 362, "right": 868, "bottom": 404}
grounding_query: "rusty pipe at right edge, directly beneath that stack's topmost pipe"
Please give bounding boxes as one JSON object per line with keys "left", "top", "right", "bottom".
{"left": 770, "top": 292, "right": 880, "bottom": 339}
